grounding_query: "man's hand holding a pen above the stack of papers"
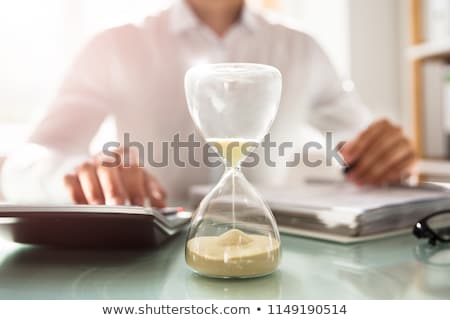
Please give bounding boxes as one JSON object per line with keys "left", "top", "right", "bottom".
{"left": 340, "top": 120, "right": 416, "bottom": 185}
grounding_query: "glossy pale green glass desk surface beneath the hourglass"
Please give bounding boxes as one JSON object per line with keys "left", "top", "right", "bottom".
{"left": 0, "top": 234, "right": 450, "bottom": 299}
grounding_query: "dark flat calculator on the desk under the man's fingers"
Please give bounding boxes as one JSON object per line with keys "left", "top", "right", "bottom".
{"left": 0, "top": 205, "right": 191, "bottom": 249}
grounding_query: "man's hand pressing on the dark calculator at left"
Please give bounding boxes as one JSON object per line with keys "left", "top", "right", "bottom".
{"left": 64, "top": 150, "right": 166, "bottom": 208}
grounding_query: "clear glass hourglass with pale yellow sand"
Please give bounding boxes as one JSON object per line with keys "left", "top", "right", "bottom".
{"left": 185, "top": 63, "right": 281, "bottom": 278}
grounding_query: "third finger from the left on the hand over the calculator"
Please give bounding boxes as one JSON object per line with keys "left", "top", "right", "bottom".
{"left": 97, "top": 165, "right": 127, "bottom": 205}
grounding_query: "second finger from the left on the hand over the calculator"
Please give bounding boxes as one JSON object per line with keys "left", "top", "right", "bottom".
{"left": 77, "top": 162, "right": 105, "bottom": 204}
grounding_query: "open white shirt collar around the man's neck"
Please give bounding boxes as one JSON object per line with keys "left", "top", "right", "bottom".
{"left": 169, "top": 0, "right": 258, "bottom": 34}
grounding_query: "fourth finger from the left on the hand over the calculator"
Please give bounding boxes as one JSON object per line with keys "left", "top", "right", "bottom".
{"left": 121, "top": 166, "right": 147, "bottom": 206}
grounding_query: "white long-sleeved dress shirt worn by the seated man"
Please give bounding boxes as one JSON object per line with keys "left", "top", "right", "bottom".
{"left": 2, "top": 0, "right": 370, "bottom": 203}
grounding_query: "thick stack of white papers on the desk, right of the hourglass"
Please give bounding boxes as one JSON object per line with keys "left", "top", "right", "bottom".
{"left": 191, "top": 182, "right": 450, "bottom": 242}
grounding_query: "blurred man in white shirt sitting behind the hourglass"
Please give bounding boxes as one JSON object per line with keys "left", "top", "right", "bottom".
{"left": 2, "top": 0, "right": 415, "bottom": 206}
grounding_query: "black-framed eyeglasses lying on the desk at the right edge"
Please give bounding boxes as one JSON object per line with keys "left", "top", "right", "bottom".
{"left": 413, "top": 209, "right": 450, "bottom": 246}
